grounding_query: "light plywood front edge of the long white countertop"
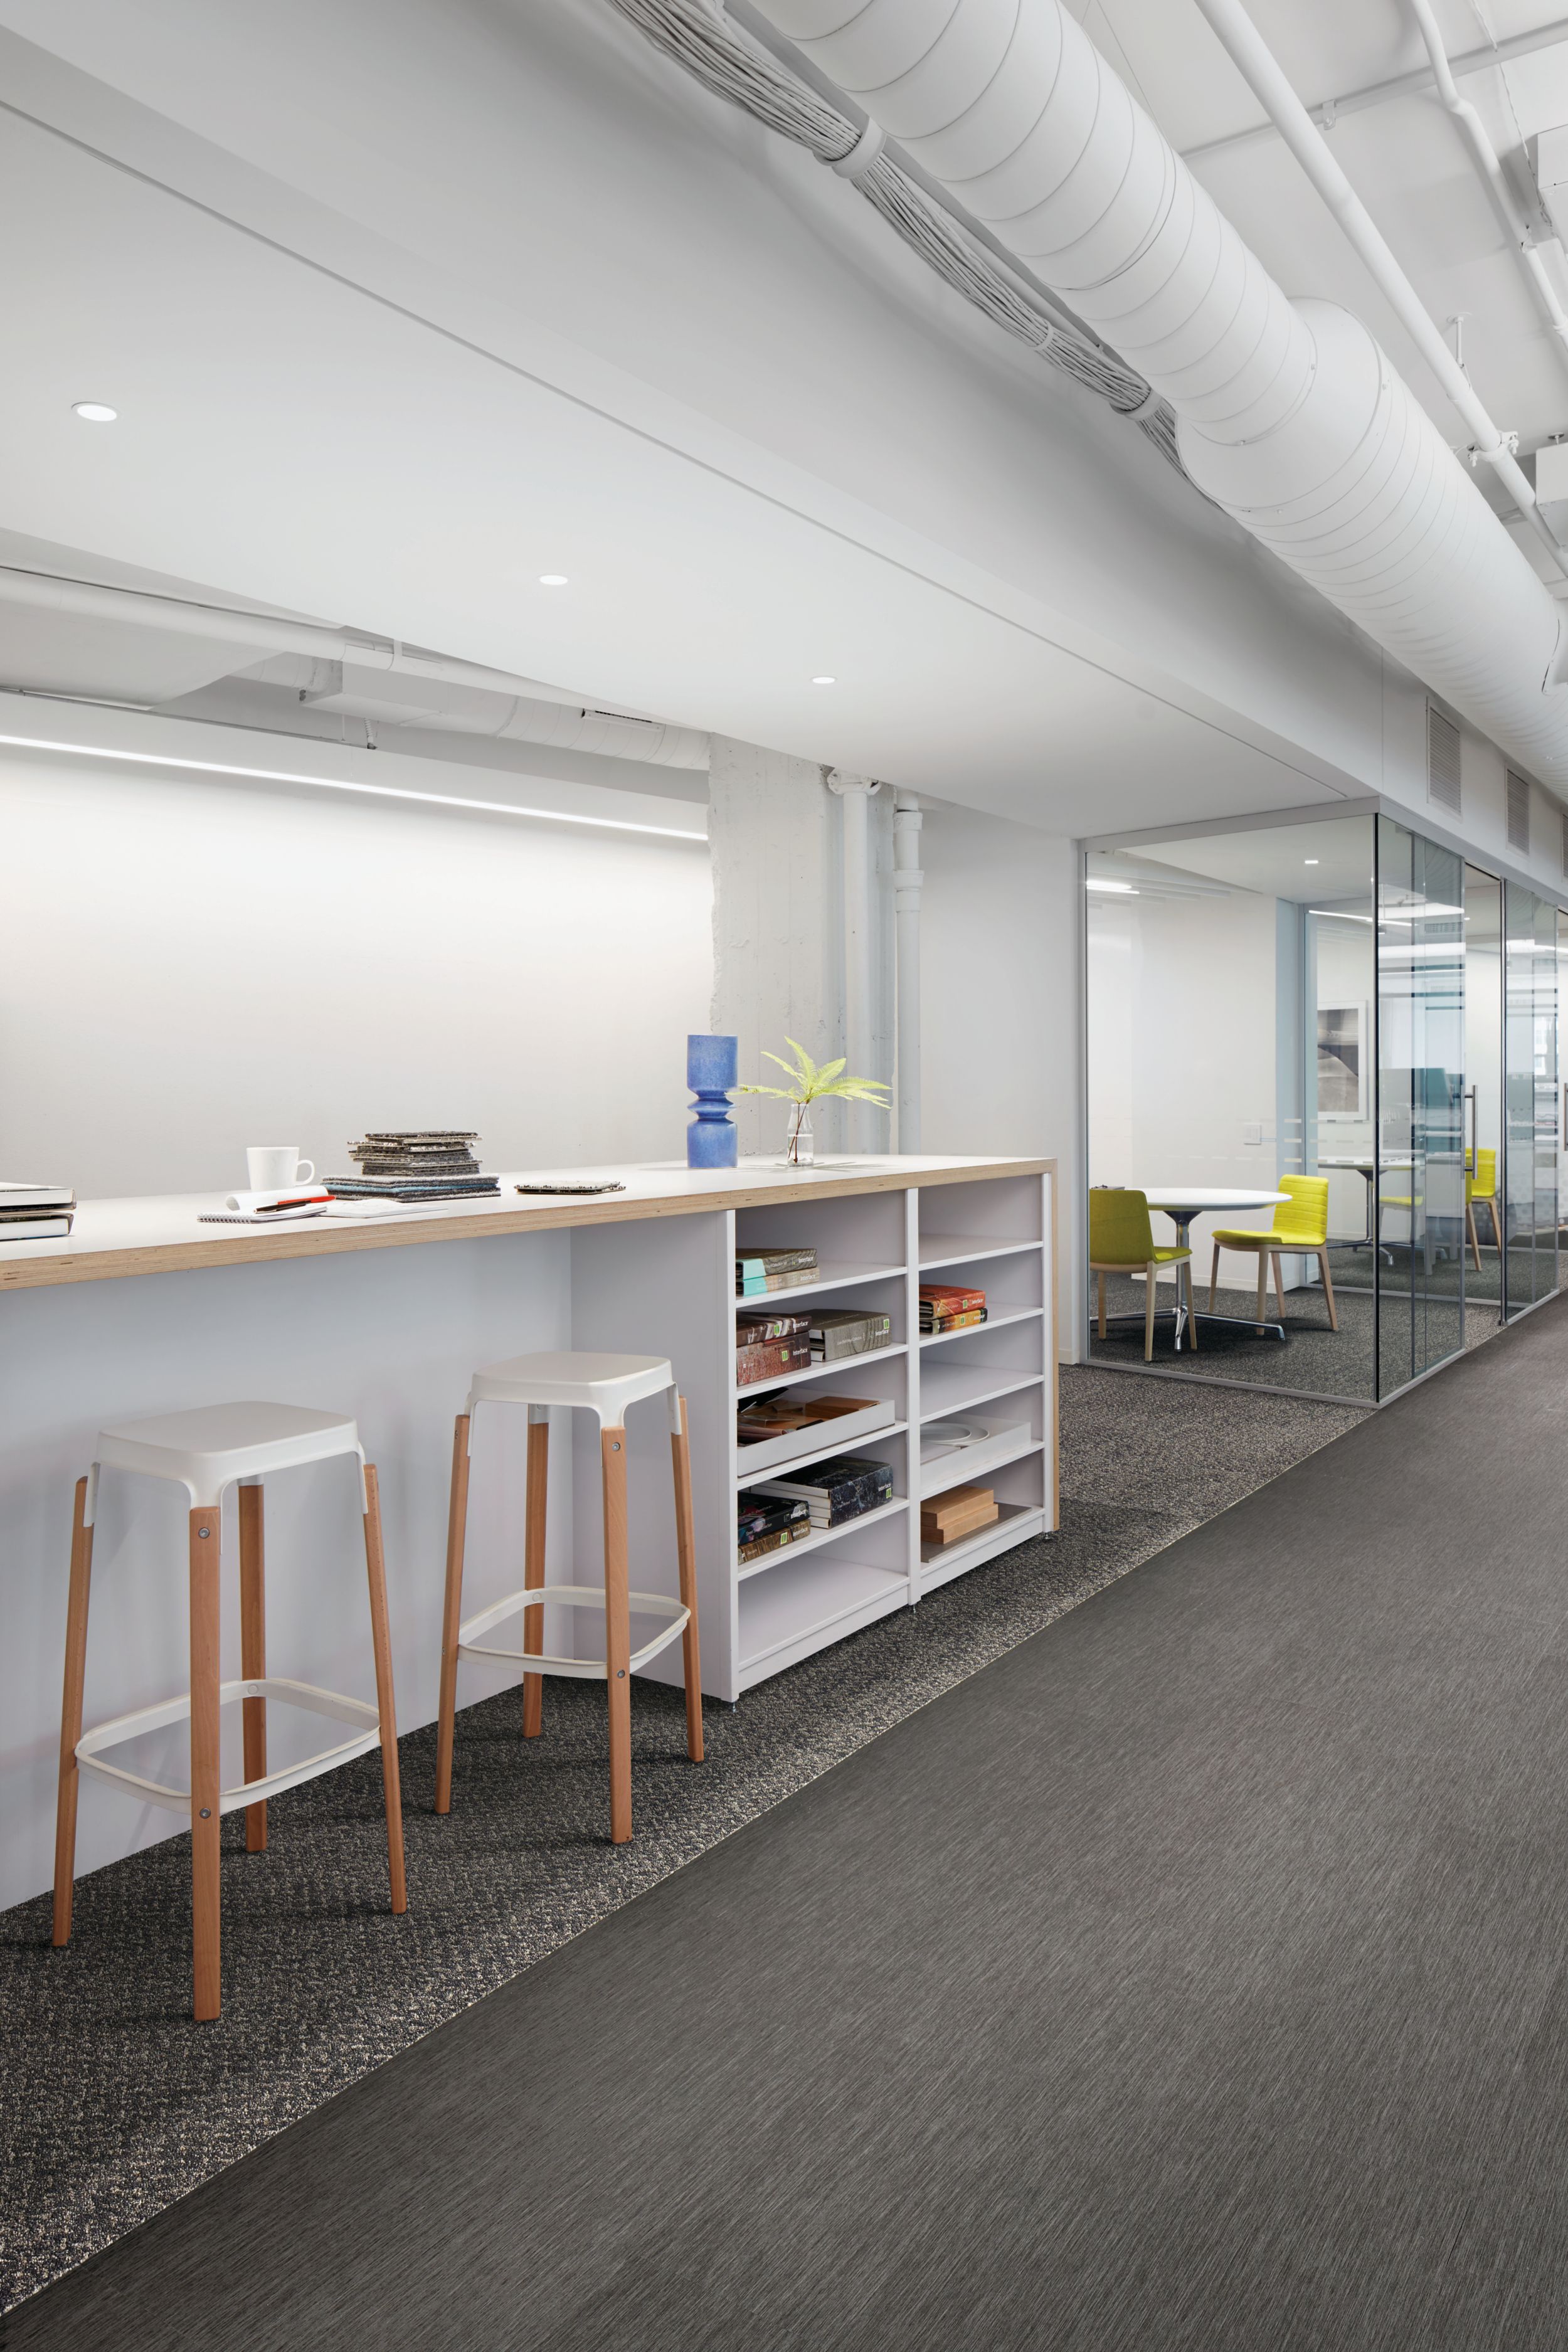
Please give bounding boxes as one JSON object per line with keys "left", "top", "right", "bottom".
{"left": 0, "top": 1160, "right": 1056, "bottom": 1291}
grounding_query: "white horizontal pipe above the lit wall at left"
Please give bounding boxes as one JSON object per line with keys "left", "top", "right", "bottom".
{"left": 0, "top": 564, "right": 707, "bottom": 767}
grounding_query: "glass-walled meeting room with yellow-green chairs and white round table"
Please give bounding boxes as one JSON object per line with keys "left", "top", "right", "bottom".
{"left": 1084, "top": 802, "right": 1568, "bottom": 1404}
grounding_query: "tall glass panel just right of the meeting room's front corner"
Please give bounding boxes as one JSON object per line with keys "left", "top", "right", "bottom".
{"left": 1377, "top": 816, "right": 1467, "bottom": 1397}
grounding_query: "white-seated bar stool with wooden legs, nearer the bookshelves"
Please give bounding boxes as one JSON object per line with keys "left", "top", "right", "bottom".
{"left": 435, "top": 1352, "right": 703, "bottom": 1846}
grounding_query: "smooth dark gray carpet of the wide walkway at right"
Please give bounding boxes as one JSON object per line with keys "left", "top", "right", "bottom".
{"left": 9, "top": 1303, "right": 1568, "bottom": 2352}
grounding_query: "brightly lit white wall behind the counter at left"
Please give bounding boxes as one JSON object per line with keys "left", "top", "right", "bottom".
{"left": 0, "top": 739, "right": 710, "bottom": 1195}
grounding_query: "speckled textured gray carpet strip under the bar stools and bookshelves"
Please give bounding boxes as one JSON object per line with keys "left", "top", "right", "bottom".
{"left": 0, "top": 1369, "right": 1357, "bottom": 2302}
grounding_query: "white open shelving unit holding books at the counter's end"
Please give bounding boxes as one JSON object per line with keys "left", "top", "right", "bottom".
{"left": 571, "top": 1173, "right": 1058, "bottom": 1700}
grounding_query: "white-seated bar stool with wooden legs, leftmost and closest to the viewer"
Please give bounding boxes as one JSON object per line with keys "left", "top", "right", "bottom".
{"left": 54, "top": 1404, "right": 406, "bottom": 2018}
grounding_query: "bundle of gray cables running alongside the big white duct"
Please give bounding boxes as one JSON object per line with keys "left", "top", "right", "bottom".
{"left": 609, "top": 0, "right": 1182, "bottom": 473}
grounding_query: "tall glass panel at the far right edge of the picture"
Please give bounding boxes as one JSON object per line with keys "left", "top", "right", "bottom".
{"left": 1502, "top": 882, "right": 1559, "bottom": 1315}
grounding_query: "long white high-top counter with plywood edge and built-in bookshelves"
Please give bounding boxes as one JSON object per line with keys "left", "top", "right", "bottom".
{"left": 0, "top": 1155, "right": 1056, "bottom": 1903}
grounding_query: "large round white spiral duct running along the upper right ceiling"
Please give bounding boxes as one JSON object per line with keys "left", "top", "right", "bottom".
{"left": 766, "top": 0, "right": 1568, "bottom": 781}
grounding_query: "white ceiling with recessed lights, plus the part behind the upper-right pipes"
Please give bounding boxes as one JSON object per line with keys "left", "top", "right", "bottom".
{"left": 0, "top": 0, "right": 1568, "bottom": 833}
